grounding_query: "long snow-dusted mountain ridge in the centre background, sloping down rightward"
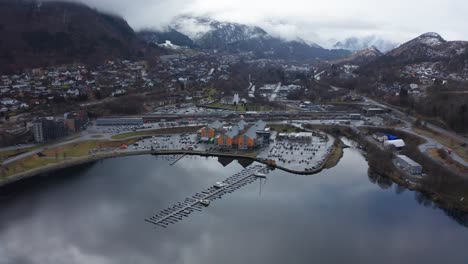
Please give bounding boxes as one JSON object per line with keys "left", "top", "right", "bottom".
{"left": 173, "top": 16, "right": 350, "bottom": 60}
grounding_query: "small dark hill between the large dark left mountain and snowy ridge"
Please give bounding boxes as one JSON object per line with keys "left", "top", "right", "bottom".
{"left": 137, "top": 28, "right": 195, "bottom": 48}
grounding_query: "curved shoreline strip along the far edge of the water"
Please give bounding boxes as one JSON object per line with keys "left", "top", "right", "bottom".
{"left": 0, "top": 145, "right": 341, "bottom": 188}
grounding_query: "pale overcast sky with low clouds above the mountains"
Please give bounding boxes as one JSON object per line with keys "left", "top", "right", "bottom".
{"left": 67, "top": 0, "right": 468, "bottom": 45}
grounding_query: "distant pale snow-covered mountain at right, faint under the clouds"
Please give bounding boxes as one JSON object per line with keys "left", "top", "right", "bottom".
{"left": 333, "top": 35, "right": 398, "bottom": 52}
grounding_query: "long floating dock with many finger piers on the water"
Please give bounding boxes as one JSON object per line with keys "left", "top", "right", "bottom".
{"left": 145, "top": 165, "right": 268, "bottom": 228}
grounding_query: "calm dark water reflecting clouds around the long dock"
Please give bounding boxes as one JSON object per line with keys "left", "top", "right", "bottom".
{"left": 0, "top": 149, "right": 468, "bottom": 264}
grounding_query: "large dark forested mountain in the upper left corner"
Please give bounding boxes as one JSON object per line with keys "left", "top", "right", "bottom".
{"left": 0, "top": 0, "right": 151, "bottom": 71}
